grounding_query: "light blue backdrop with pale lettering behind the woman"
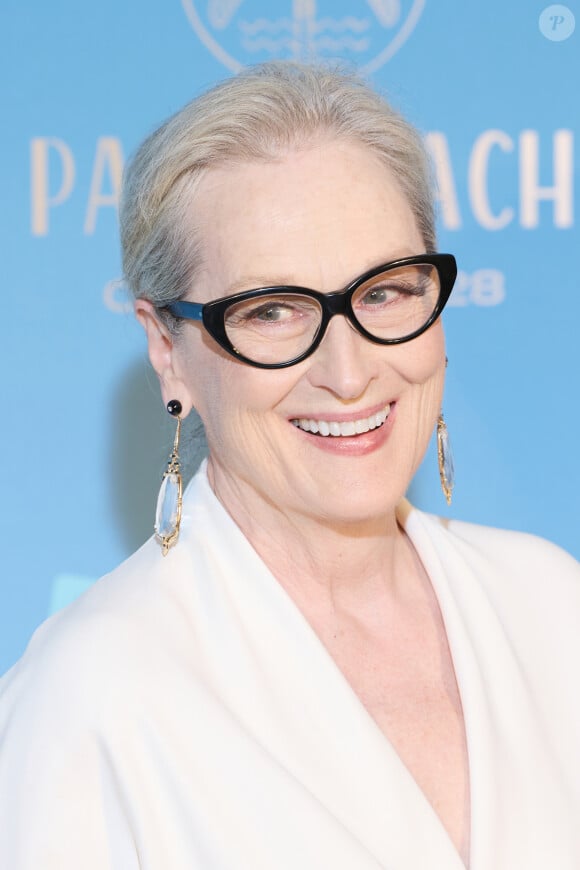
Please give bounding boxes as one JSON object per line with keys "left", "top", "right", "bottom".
{"left": 0, "top": 0, "right": 580, "bottom": 672}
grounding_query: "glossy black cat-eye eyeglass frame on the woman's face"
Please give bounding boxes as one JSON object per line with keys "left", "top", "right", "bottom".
{"left": 160, "top": 253, "right": 457, "bottom": 369}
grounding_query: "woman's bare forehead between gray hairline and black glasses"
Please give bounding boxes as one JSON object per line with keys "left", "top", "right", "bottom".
{"left": 190, "top": 142, "right": 424, "bottom": 300}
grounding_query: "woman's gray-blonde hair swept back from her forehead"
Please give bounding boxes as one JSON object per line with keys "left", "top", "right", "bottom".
{"left": 120, "top": 61, "right": 435, "bottom": 318}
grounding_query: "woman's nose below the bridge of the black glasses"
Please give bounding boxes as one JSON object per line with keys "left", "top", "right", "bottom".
{"left": 308, "top": 316, "right": 385, "bottom": 400}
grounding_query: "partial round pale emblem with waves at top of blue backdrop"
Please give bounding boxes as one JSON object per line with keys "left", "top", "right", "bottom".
{"left": 181, "top": 0, "right": 426, "bottom": 73}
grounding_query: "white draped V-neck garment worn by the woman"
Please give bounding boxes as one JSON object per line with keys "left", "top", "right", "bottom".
{"left": 0, "top": 472, "right": 580, "bottom": 870}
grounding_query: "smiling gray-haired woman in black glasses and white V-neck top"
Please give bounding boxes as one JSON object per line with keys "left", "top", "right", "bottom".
{"left": 0, "top": 63, "right": 580, "bottom": 870}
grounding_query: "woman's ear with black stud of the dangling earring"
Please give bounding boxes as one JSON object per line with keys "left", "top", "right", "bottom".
{"left": 135, "top": 299, "right": 193, "bottom": 417}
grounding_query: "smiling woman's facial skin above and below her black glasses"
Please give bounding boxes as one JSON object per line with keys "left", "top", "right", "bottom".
{"left": 159, "top": 142, "right": 445, "bottom": 523}
